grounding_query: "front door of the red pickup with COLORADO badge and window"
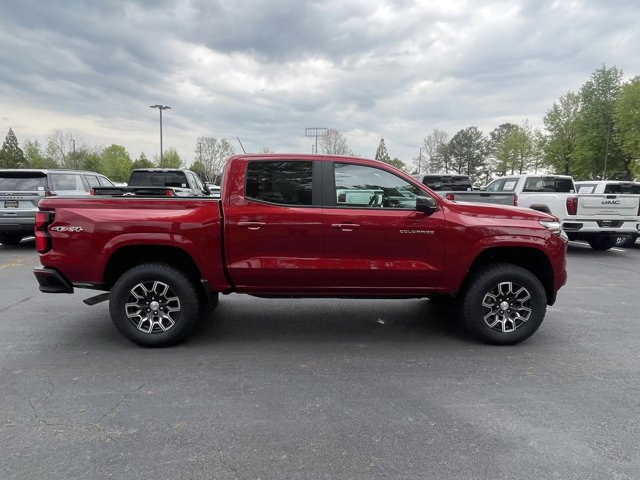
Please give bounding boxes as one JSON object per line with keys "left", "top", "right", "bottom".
{"left": 323, "top": 162, "right": 445, "bottom": 295}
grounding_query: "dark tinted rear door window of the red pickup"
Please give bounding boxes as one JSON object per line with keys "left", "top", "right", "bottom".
{"left": 245, "top": 161, "right": 313, "bottom": 205}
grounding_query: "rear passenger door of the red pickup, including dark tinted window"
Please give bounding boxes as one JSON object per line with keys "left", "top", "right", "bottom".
{"left": 224, "top": 159, "right": 324, "bottom": 294}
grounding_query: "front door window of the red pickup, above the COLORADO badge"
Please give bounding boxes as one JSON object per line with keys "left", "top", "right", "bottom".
{"left": 334, "top": 163, "right": 421, "bottom": 210}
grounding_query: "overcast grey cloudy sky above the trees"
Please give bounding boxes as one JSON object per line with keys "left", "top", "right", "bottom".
{"left": 0, "top": 0, "right": 640, "bottom": 163}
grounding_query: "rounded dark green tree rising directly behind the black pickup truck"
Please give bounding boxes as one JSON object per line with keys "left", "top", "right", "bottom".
{"left": 447, "top": 127, "right": 488, "bottom": 183}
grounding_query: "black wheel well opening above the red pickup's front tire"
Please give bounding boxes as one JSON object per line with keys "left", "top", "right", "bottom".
{"left": 462, "top": 247, "right": 556, "bottom": 305}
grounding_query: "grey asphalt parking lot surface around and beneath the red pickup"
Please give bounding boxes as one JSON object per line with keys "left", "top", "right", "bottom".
{"left": 0, "top": 242, "right": 640, "bottom": 480}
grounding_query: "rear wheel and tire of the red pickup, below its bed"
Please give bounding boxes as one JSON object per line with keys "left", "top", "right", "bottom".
{"left": 109, "top": 263, "right": 200, "bottom": 347}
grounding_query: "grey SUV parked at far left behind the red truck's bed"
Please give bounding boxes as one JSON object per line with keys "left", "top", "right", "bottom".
{"left": 0, "top": 169, "right": 113, "bottom": 245}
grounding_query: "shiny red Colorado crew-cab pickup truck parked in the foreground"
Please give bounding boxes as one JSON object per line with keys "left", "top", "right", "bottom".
{"left": 34, "top": 154, "right": 567, "bottom": 347}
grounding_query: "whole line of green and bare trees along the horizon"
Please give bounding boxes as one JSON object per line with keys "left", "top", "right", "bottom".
{"left": 0, "top": 66, "right": 640, "bottom": 184}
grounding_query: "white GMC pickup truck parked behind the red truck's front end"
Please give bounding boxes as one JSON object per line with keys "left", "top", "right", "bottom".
{"left": 485, "top": 175, "right": 640, "bottom": 250}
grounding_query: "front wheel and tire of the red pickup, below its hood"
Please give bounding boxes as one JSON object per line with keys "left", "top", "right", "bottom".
{"left": 462, "top": 263, "right": 547, "bottom": 345}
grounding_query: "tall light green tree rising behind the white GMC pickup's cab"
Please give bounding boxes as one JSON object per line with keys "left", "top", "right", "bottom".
{"left": 543, "top": 92, "right": 580, "bottom": 175}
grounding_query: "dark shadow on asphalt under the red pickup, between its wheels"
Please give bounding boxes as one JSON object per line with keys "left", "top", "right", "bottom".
{"left": 189, "top": 295, "right": 473, "bottom": 344}
